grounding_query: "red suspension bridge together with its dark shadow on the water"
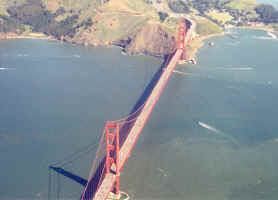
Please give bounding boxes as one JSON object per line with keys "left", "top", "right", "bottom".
{"left": 50, "top": 19, "right": 191, "bottom": 200}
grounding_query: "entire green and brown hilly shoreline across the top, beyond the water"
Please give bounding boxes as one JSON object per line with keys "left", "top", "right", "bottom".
{"left": 0, "top": 0, "right": 278, "bottom": 55}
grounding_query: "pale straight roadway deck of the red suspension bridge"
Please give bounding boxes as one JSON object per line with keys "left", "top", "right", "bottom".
{"left": 94, "top": 49, "right": 183, "bottom": 200}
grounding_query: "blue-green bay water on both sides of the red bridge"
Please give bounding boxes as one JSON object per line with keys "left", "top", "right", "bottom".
{"left": 0, "top": 31, "right": 278, "bottom": 200}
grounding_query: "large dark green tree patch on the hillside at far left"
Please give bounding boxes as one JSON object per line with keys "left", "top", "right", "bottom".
{"left": 0, "top": 0, "right": 92, "bottom": 38}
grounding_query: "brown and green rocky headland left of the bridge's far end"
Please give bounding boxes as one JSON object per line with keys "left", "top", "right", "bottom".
{"left": 0, "top": 0, "right": 182, "bottom": 56}
